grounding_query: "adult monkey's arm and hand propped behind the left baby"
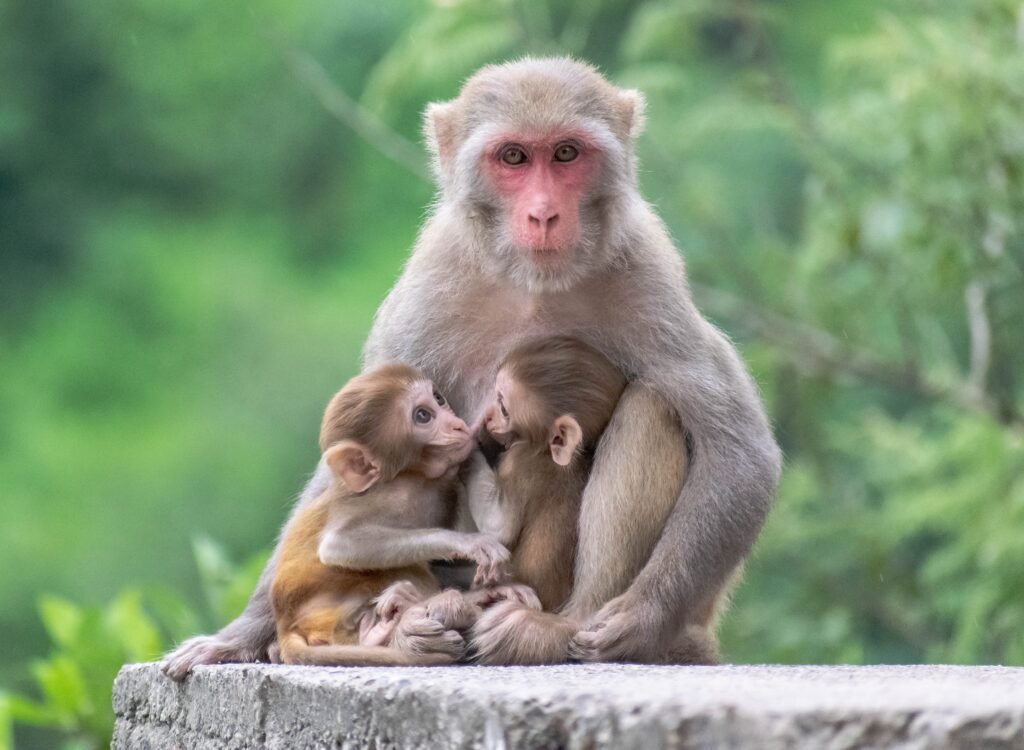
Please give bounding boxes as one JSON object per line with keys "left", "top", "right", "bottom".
{"left": 163, "top": 461, "right": 330, "bottom": 680}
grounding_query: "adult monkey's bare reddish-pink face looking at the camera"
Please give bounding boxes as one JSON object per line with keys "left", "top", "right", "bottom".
{"left": 485, "top": 133, "right": 598, "bottom": 266}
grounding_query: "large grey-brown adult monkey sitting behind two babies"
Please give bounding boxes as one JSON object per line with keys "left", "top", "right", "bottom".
{"left": 165, "top": 52, "right": 781, "bottom": 678}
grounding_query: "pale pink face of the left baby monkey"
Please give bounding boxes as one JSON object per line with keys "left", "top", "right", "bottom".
{"left": 406, "top": 380, "right": 474, "bottom": 476}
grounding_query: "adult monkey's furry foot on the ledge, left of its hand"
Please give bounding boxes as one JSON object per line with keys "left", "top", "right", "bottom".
{"left": 470, "top": 601, "right": 580, "bottom": 665}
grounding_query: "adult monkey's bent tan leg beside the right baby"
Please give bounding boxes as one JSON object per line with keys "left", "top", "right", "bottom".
{"left": 562, "top": 384, "right": 688, "bottom": 622}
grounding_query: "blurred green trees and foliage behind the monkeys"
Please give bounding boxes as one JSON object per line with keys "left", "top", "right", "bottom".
{"left": 0, "top": 0, "right": 1024, "bottom": 746}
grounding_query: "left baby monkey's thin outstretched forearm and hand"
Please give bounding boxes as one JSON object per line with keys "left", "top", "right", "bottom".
{"left": 316, "top": 524, "right": 509, "bottom": 583}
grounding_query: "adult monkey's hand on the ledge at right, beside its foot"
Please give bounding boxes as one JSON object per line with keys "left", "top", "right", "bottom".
{"left": 569, "top": 591, "right": 665, "bottom": 662}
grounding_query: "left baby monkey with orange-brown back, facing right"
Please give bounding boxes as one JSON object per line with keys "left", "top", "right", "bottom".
{"left": 271, "top": 365, "right": 509, "bottom": 666}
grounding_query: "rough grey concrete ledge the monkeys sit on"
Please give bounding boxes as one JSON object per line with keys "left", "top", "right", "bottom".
{"left": 114, "top": 664, "right": 1024, "bottom": 750}
